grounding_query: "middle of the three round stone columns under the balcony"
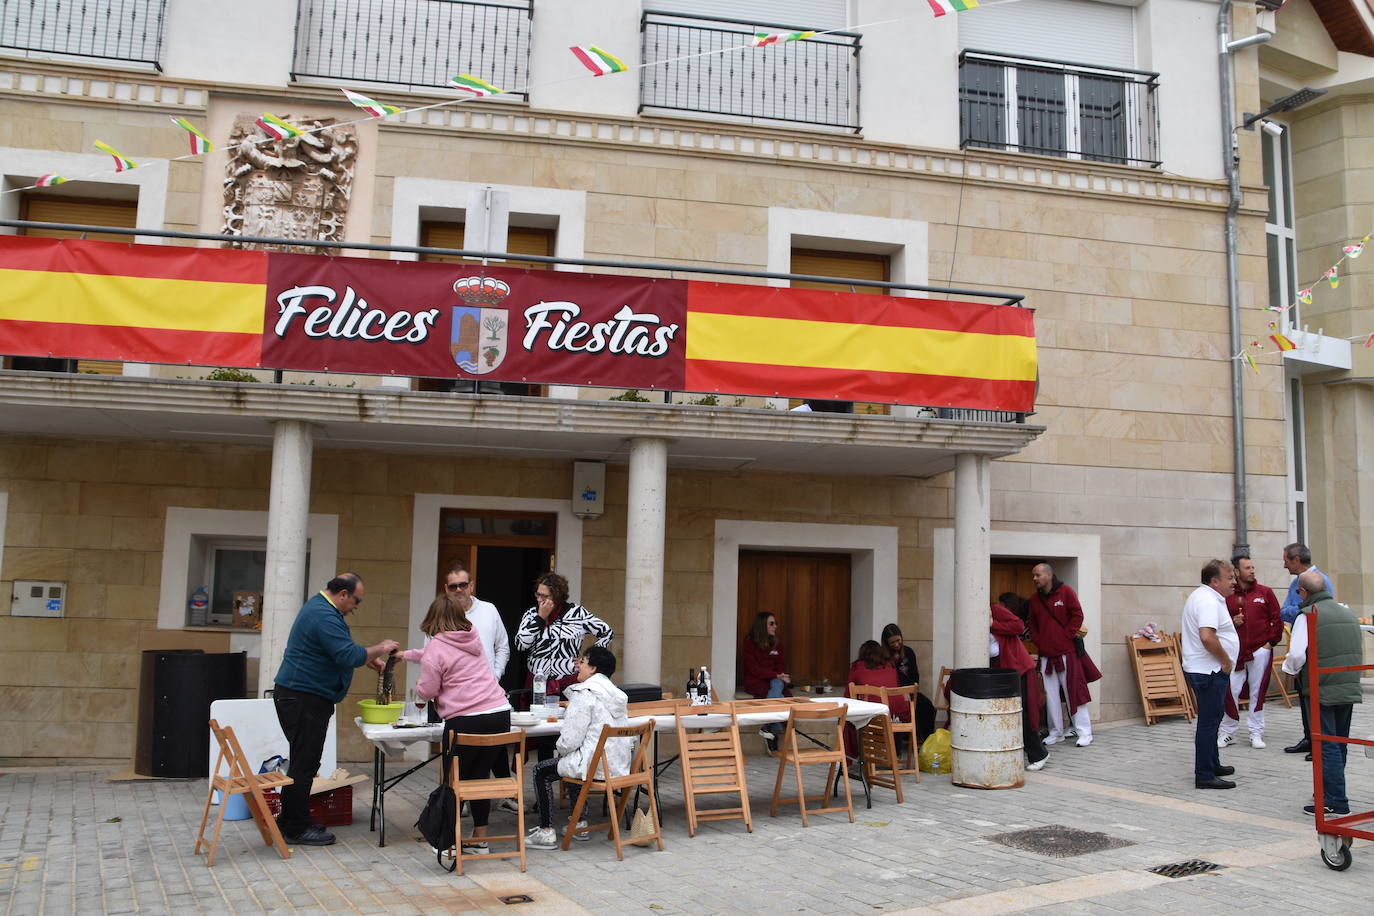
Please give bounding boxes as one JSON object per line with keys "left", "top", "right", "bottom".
{"left": 620, "top": 439, "right": 668, "bottom": 684}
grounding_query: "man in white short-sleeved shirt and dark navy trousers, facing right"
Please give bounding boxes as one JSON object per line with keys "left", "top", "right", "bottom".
{"left": 1182, "top": 560, "right": 1241, "bottom": 788}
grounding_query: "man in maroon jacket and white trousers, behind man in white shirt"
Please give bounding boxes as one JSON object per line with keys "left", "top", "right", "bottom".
{"left": 1216, "top": 556, "right": 1283, "bottom": 748}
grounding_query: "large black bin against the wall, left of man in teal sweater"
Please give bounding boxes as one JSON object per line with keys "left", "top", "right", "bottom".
{"left": 133, "top": 648, "right": 247, "bottom": 777}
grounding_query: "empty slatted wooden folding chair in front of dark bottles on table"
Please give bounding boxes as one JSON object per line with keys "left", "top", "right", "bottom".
{"left": 676, "top": 703, "right": 754, "bottom": 836}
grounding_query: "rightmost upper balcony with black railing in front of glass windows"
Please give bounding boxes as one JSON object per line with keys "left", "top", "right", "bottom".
{"left": 959, "top": 51, "right": 1160, "bottom": 168}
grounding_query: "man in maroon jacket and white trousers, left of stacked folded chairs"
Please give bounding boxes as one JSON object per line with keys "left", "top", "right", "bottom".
{"left": 1028, "top": 563, "right": 1102, "bottom": 747}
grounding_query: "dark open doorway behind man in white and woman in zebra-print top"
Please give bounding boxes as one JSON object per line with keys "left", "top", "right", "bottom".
{"left": 434, "top": 508, "right": 558, "bottom": 689}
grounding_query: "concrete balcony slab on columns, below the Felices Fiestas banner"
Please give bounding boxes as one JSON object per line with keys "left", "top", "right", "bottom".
{"left": 0, "top": 372, "right": 1044, "bottom": 477}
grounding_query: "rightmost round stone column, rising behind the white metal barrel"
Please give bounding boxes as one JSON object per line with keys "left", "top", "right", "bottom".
{"left": 954, "top": 455, "right": 991, "bottom": 667}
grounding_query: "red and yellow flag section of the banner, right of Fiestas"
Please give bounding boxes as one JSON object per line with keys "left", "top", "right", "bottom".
{"left": 686, "top": 283, "right": 1036, "bottom": 412}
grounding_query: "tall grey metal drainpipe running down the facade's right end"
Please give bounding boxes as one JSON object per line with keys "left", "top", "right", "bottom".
{"left": 1216, "top": 0, "right": 1250, "bottom": 556}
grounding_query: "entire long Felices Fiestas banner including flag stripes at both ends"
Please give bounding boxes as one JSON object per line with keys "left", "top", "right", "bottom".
{"left": 0, "top": 236, "right": 1036, "bottom": 412}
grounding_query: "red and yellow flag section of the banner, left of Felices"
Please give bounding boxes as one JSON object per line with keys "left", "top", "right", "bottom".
{"left": 0, "top": 236, "right": 267, "bottom": 367}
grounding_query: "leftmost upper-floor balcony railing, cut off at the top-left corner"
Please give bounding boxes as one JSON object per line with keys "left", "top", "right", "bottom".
{"left": 0, "top": 0, "right": 166, "bottom": 70}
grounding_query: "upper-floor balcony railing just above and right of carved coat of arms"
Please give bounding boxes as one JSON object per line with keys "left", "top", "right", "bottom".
{"left": 291, "top": 0, "right": 533, "bottom": 99}
